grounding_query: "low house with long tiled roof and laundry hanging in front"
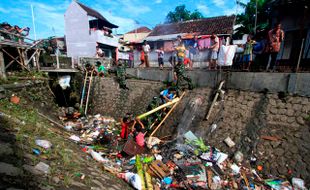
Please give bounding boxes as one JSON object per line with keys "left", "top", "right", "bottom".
{"left": 142, "top": 15, "right": 235, "bottom": 67}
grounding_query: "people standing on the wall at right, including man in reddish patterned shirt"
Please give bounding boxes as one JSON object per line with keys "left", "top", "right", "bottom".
{"left": 242, "top": 23, "right": 284, "bottom": 71}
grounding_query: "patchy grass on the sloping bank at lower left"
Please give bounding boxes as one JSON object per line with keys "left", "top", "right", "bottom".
{"left": 0, "top": 99, "right": 81, "bottom": 187}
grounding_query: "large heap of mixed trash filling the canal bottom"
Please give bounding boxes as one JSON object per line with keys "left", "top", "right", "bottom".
{"left": 64, "top": 115, "right": 306, "bottom": 190}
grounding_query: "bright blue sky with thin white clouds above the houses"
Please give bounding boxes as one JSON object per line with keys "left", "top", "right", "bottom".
{"left": 0, "top": 0, "right": 248, "bottom": 39}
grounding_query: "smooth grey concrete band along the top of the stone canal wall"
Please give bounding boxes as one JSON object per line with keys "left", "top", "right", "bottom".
{"left": 127, "top": 68, "right": 310, "bottom": 96}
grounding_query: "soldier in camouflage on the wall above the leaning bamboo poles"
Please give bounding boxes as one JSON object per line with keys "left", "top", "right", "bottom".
{"left": 174, "top": 61, "right": 193, "bottom": 93}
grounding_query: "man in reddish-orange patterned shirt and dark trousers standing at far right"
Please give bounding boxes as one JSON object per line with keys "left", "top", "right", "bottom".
{"left": 268, "top": 23, "right": 284, "bottom": 71}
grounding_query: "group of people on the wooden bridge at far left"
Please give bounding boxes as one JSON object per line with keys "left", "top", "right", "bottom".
{"left": 0, "top": 22, "right": 30, "bottom": 43}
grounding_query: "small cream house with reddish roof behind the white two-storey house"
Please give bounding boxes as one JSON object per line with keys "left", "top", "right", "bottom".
{"left": 124, "top": 26, "right": 152, "bottom": 43}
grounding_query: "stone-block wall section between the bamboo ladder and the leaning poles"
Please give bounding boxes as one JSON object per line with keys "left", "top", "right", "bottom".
{"left": 92, "top": 78, "right": 162, "bottom": 118}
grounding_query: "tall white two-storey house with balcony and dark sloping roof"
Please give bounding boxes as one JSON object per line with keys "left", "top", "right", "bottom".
{"left": 65, "top": 1, "right": 118, "bottom": 62}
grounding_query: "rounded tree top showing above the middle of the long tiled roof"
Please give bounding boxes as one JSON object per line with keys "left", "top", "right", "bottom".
{"left": 166, "top": 5, "right": 203, "bottom": 23}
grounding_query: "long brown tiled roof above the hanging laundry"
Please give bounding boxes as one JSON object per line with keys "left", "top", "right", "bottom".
{"left": 149, "top": 15, "right": 235, "bottom": 36}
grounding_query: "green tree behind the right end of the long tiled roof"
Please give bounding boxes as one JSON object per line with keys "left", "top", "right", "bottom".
{"left": 235, "top": 0, "right": 270, "bottom": 37}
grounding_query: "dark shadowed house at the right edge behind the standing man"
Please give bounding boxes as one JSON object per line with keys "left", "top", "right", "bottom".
{"left": 269, "top": 0, "right": 310, "bottom": 70}
